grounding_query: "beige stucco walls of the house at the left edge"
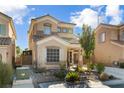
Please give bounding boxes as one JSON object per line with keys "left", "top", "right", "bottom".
{"left": 0, "top": 14, "right": 16, "bottom": 63}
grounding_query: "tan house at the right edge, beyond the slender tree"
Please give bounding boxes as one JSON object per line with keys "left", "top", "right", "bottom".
{"left": 94, "top": 24, "right": 124, "bottom": 66}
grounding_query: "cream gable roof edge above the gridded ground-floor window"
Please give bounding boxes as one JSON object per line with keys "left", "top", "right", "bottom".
{"left": 37, "top": 36, "right": 70, "bottom": 45}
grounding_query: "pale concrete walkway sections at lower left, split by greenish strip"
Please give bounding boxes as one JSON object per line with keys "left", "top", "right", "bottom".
{"left": 12, "top": 67, "right": 34, "bottom": 88}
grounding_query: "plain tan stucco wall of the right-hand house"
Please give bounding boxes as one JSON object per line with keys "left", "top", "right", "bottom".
{"left": 95, "top": 27, "right": 124, "bottom": 65}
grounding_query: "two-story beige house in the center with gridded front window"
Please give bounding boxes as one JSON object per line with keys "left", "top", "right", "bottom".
{"left": 28, "top": 15, "right": 82, "bottom": 69}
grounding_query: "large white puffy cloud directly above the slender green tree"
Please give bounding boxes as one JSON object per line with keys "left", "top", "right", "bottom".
{"left": 71, "top": 8, "right": 98, "bottom": 28}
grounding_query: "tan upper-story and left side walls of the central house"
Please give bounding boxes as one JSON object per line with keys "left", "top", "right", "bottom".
{"left": 28, "top": 17, "right": 74, "bottom": 62}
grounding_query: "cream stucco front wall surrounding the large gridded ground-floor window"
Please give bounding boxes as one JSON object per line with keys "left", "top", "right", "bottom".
{"left": 37, "top": 40, "right": 67, "bottom": 68}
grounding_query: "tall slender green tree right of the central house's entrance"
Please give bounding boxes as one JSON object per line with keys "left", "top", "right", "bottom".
{"left": 80, "top": 25, "right": 95, "bottom": 66}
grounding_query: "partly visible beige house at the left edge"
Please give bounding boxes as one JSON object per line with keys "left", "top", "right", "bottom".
{"left": 0, "top": 12, "right": 16, "bottom": 64}
